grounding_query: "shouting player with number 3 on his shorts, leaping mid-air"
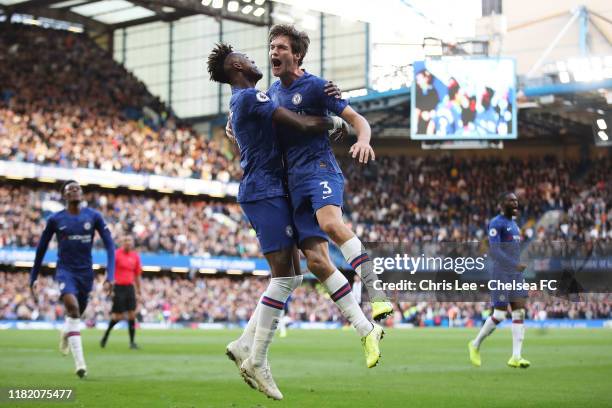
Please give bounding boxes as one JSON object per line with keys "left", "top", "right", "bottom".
{"left": 268, "top": 25, "right": 393, "bottom": 324}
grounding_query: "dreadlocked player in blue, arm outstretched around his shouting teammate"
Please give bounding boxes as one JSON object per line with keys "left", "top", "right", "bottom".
{"left": 208, "top": 44, "right": 354, "bottom": 399}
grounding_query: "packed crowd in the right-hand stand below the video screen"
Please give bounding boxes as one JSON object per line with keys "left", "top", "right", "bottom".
{"left": 341, "top": 156, "right": 612, "bottom": 243}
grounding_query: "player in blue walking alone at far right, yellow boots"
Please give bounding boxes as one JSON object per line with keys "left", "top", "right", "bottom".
{"left": 468, "top": 192, "right": 531, "bottom": 368}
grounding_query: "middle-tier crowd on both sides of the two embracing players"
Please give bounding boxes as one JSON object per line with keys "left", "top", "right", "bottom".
{"left": 0, "top": 156, "right": 612, "bottom": 257}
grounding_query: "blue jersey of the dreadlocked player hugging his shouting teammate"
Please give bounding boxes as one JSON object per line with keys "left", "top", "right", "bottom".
{"left": 230, "top": 88, "right": 287, "bottom": 202}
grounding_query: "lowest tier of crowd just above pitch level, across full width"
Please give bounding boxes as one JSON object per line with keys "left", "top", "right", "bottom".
{"left": 0, "top": 272, "right": 612, "bottom": 326}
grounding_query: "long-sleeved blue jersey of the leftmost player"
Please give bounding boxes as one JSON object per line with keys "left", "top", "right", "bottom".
{"left": 30, "top": 207, "right": 115, "bottom": 281}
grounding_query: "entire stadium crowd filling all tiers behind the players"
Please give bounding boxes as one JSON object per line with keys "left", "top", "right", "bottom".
{"left": 0, "top": 24, "right": 612, "bottom": 325}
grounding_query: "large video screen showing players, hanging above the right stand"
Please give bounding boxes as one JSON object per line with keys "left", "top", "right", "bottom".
{"left": 410, "top": 58, "right": 516, "bottom": 140}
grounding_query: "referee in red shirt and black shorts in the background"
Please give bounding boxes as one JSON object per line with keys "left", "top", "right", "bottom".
{"left": 100, "top": 235, "right": 142, "bottom": 349}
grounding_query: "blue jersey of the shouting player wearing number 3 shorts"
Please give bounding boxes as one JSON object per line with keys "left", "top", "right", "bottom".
{"left": 268, "top": 72, "right": 348, "bottom": 186}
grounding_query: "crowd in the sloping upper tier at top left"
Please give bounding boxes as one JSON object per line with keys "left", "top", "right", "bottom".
{"left": 0, "top": 24, "right": 240, "bottom": 181}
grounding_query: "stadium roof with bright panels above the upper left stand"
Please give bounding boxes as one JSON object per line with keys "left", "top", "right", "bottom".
{"left": 0, "top": 0, "right": 270, "bottom": 32}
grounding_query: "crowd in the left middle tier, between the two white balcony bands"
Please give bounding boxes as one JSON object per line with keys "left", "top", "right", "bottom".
{"left": 0, "top": 185, "right": 260, "bottom": 257}
